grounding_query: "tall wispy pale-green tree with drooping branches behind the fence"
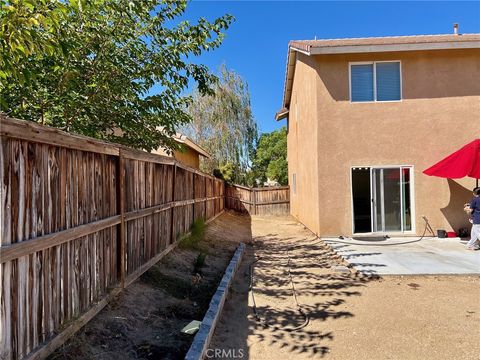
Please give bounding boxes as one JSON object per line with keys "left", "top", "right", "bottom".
{"left": 181, "top": 65, "right": 257, "bottom": 183}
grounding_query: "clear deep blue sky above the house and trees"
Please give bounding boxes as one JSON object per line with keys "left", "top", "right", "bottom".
{"left": 178, "top": 0, "right": 480, "bottom": 132}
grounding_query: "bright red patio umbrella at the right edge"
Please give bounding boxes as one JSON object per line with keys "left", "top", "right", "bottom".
{"left": 423, "top": 139, "right": 480, "bottom": 186}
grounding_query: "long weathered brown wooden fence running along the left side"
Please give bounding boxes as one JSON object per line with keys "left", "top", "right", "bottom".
{"left": 0, "top": 115, "right": 224, "bottom": 359}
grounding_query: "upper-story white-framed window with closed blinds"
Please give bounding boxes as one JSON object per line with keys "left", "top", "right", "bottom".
{"left": 350, "top": 61, "right": 402, "bottom": 102}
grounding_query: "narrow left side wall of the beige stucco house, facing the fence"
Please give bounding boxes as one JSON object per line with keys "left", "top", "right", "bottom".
{"left": 287, "top": 54, "right": 320, "bottom": 233}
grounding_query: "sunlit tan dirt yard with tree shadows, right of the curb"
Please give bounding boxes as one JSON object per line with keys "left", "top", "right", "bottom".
{"left": 211, "top": 217, "right": 480, "bottom": 360}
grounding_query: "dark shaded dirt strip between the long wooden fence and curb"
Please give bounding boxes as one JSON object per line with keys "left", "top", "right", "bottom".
{"left": 50, "top": 213, "right": 251, "bottom": 360}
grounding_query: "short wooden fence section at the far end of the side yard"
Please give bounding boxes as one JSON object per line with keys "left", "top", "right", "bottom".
{"left": 225, "top": 185, "right": 290, "bottom": 215}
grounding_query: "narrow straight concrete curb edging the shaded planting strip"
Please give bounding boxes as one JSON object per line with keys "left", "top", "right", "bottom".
{"left": 185, "top": 243, "right": 245, "bottom": 360}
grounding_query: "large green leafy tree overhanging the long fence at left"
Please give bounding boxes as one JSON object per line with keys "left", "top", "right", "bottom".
{"left": 0, "top": 0, "right": 233, "bottom": 150}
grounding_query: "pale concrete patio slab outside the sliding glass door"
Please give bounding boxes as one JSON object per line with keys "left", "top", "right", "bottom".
{"left": 322, "top": 238, "right": 480, "bottom": 275}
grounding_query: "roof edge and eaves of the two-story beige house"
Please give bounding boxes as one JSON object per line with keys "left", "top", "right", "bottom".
{"left": 275, "top": 34, "right": 480, "bottom": 120}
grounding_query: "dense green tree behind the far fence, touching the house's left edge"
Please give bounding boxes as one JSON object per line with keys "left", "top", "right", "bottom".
{"left": 253, "top": 127, "right": 288, "bottom": 185}
